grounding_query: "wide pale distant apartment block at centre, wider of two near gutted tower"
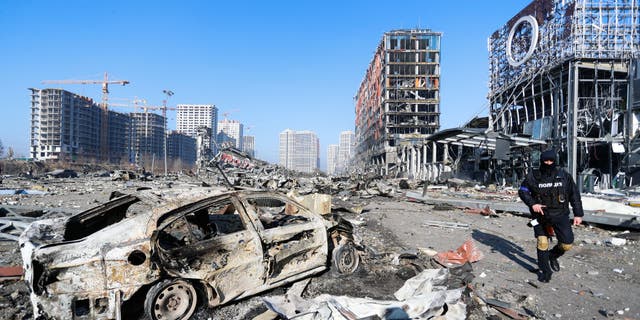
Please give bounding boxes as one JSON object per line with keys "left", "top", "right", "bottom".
{"left": 280, "top": 129, "right": 320, "bottom": 173}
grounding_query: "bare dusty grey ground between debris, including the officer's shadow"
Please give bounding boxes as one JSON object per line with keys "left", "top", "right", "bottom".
{"left": 0, "top": 178, "right": 640, "bottom": 319}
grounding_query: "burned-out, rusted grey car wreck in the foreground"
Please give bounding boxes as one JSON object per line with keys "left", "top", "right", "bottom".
{"left": 19, "top": 187, "right": 361, "bottom": 319}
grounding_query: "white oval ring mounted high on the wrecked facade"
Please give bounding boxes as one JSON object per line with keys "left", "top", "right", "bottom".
{"left": 507, "top": 16, "right": 538, "bottom": 67}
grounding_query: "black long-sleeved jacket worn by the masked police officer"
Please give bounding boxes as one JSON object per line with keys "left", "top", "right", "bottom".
{"left": 518, "top": 168, "right": 584, "bottom": 217}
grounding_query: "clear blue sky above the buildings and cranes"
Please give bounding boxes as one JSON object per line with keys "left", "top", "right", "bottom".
{"left": 0, "top": 0, "right": 530, "bottom": 168}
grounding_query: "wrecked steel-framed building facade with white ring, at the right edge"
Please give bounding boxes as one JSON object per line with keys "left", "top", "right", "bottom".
{"left": 481, "top": 0, "right": 640, "bottom": 188}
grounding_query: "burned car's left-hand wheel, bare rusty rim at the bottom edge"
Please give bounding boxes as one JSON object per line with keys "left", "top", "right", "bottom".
{"left": 144, "top": 279, "right": 198, "bottom": 320}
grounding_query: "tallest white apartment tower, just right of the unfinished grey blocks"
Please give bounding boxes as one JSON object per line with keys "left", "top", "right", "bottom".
{"left": 176, "top": 104, "right": 218, "bottom": 163}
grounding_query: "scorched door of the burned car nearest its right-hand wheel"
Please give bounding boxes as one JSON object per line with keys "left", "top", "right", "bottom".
{"left": 243, "top": 193, "right": 328, "bottom": 284}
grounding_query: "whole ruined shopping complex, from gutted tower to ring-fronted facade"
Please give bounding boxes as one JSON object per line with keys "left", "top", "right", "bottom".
{"left": 356, "top": 0, "right": 640, "bottom": 189}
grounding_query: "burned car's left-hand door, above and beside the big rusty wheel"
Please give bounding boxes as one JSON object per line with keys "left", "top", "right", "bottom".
{"left": 154, "top": 196, "right": 265, "bottom": 306}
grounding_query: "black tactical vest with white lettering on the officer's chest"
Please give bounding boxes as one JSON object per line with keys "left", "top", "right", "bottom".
{"left": 533, "top": 169, "right": 569, "bottom": 216}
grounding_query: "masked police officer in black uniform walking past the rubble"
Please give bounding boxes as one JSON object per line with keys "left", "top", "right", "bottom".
{"left": 518, "top": 150, "right": 584, "bottom": 282}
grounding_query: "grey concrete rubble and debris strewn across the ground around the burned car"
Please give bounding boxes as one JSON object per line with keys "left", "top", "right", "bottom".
{"left": 0, "top": 150, "right": 640, "bottom": 319}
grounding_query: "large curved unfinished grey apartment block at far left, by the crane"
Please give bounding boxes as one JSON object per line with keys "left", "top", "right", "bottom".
{"left": 29, "top": 88, "right": 131, "bottom": 163}
